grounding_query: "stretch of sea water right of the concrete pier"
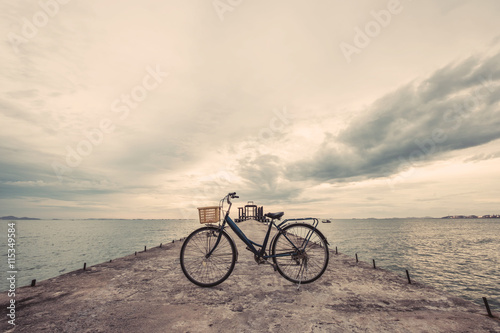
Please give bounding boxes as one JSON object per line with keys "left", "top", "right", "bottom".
{"left": 320, "top": 219, "right": 500, "bottom": 311}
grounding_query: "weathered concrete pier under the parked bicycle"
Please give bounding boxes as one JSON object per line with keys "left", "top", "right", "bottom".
{"left": 0, "top": 221, "right": 500, "bottom": 333}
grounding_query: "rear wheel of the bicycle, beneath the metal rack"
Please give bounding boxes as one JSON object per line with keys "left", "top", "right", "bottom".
{"left": 272, "top": 223, "right": 330, "bottom": 283}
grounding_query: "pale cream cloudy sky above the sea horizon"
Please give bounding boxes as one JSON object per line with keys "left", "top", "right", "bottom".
{"left": 0, "top": 0, "right": 500, "bottom": 219}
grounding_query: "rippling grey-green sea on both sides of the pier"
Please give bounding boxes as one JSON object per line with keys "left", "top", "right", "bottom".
{"left": 0, "top": 218, "right": 500, "bottom": 312}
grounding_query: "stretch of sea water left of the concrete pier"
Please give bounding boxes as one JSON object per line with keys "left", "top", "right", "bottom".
{"left": 0, "top": 220, "right": 200, "bottom": 291}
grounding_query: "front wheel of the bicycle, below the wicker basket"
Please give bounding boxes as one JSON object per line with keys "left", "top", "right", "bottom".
{"left": 180, "top": 227, "right": 236, "bottom": 287}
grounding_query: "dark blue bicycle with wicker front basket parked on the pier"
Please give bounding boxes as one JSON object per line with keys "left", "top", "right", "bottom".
{"left": 180, "top": 192, "right": 329, "bottom": 287}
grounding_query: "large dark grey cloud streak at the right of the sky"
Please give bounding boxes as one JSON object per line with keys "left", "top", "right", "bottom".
{"left": 286, "top": 53, "right": 500, "bottom": 182}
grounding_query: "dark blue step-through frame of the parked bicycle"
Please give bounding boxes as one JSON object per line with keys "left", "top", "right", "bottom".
{"left": 206, "top": 197, "right": 319, "bottom": 259}
